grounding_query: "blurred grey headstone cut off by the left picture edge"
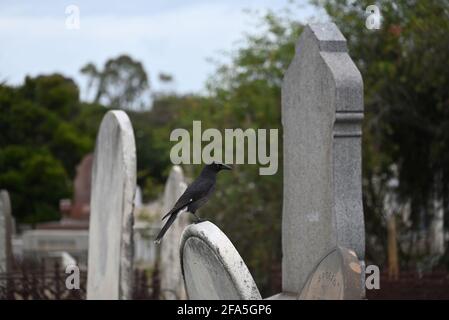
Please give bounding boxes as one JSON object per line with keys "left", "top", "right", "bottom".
{"left": 0, "top": 190, "right": 13, "bottom": 276}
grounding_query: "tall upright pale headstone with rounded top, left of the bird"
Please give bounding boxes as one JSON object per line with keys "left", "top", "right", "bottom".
{"left": 87, "top": 111, "right": 136, "bottom": 299}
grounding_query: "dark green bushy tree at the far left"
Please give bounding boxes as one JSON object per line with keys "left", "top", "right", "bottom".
{"left": 0, "top": 74, "right": 93, "bottom": 223}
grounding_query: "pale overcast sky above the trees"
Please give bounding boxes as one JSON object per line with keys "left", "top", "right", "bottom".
{"left": 0, "top": 0, "right": 322, "bottom": 99}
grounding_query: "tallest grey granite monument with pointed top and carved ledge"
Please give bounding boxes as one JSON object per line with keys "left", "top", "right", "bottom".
{"left": 282, "top": 23, "right": 365, "bottom": 293}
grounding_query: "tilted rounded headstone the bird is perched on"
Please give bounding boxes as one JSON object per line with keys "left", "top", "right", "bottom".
{"left": 180, "top": 221, "right": 261, "bottom": 300}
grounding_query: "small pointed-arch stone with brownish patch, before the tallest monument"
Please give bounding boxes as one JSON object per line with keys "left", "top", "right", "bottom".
{"left": 299, "top": 247, "right": 363, "bottom": 300}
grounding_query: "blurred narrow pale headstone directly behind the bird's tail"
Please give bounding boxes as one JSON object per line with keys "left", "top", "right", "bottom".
{"left": 160, "top": 166, "right": 189, "bottom": 299}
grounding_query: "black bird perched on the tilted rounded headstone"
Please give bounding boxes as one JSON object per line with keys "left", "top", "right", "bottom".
{"left": 154, "top": 162, "right": 231, "bottom": 243}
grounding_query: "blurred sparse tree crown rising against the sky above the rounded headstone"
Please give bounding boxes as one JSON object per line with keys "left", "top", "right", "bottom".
{"left": 80, "top": 55, "right": 149, "bottom": 109}
